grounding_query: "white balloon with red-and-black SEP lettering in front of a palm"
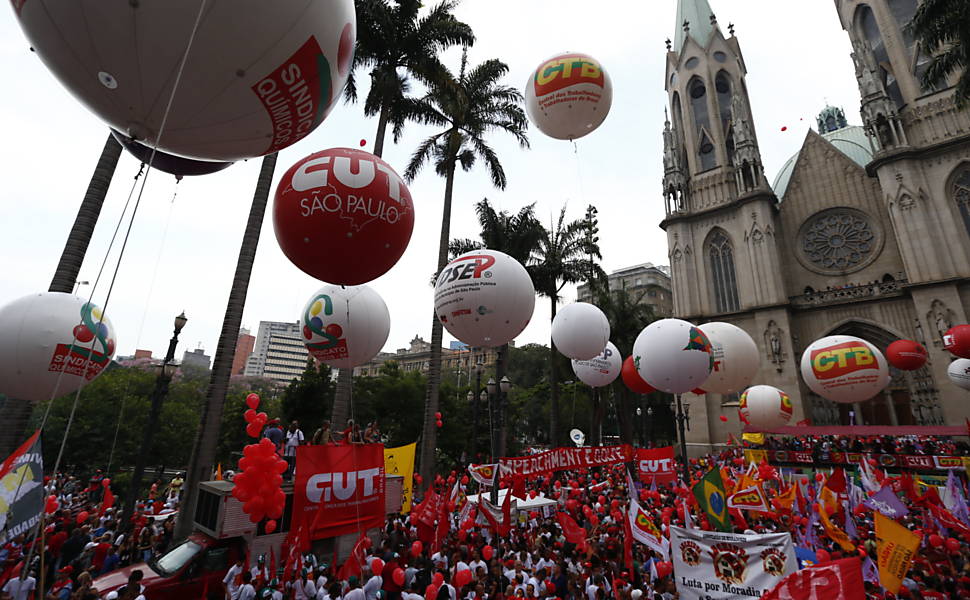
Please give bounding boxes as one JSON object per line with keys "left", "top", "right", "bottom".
{"left": 434, "top": 249, "right": 532, "bottom": 350}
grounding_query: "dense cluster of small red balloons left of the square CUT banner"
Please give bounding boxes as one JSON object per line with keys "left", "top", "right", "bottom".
{"left": 232, "top": 438, "right": 287, "bottom": 530}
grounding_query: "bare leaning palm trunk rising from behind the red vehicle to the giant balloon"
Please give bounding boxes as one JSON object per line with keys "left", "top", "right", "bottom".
{"left": 174, "top": 153, "right": 277, "bottom": 540}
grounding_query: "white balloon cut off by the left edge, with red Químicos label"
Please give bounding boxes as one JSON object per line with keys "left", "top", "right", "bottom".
{"left": 0, "top": 292, "right": 117, "bottom": 402}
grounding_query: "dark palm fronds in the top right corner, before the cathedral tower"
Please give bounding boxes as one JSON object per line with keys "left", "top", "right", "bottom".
{"left": 906, "top": 0, "right": 970, "bottom": 108}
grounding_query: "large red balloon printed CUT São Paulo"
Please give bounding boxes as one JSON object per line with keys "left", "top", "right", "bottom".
{"left": 273, "top": 148, "right": 414, "bottom": 285}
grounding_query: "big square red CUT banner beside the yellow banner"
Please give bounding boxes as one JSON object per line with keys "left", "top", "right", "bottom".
{"left": 290, "top": 444, "right": 384, "bottom": 539}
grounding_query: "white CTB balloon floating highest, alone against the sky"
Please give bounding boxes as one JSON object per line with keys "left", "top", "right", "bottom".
{"left": 525, "top": 52, "right": 613, "bottom": 140}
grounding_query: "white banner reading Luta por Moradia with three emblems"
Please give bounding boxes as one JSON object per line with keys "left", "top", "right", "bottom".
{"left": 670, "top": 527, "right": 798, "bottom": 600}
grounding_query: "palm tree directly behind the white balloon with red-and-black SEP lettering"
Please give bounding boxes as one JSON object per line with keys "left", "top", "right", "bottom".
{"left": 449, "top": 198, "right": 546, "bottom": 456}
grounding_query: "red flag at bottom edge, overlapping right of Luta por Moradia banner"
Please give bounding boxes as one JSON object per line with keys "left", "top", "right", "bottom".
{"left": 761, "top": 556, "right": 866, "bottom": 600}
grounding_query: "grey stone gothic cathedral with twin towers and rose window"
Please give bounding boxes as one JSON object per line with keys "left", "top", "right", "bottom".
{"left": 661, "top": 0, "right": 970, "bottom": 444}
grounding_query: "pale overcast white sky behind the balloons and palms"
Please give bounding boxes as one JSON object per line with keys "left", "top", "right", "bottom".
{"left": 0, "top": 0, "right": 860, "bottom": 356}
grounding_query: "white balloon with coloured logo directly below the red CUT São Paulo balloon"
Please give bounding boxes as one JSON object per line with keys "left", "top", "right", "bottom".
{"left": 300, "top": 284, "right": 391, "bottom": 369}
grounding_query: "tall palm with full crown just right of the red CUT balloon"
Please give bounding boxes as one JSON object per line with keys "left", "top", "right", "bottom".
{"left": 404, "top": 49, "right": 529, "bottom": 481}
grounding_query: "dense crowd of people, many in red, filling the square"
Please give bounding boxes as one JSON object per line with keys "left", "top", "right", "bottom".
{"left": 0, "top": 436, "right": 970, "bottom": 600}
